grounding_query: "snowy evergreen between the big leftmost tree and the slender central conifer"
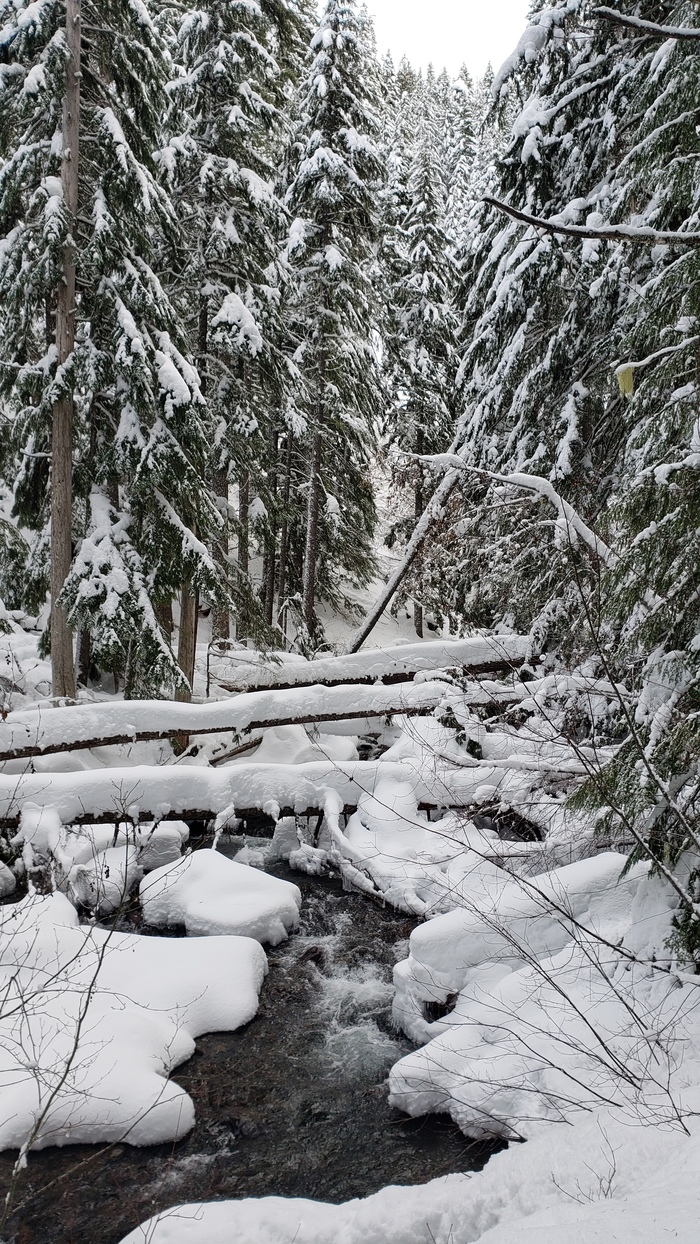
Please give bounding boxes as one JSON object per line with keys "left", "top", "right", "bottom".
{"left": 160, "top": 0, "right": 310, "bottom": 661}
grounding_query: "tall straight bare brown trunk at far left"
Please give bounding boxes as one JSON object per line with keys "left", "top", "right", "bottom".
{"left": 51, "top": 0, "right": 81, "bottom": 698}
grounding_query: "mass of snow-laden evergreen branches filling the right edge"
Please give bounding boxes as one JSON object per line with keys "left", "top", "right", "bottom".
{"left": 437, "top": 2, "right": 700, "bottom": 940}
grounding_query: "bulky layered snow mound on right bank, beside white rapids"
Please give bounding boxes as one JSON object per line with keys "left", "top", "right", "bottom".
{"left": 389, "top": 852, "right": 700, "bottom": 1138}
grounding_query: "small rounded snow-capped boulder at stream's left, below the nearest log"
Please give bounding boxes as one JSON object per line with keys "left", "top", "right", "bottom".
{"left": 140, "top": 851, "right": 301, "bottom": 945}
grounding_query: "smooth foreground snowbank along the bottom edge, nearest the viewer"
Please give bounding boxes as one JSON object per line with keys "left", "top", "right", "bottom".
{"left": 116, "top": 1115, "right": 700, "bottom": 1244}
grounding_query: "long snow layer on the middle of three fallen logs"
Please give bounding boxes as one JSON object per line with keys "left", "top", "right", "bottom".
{"left": 0, "top": 680, "right": 445, "bottom": 763}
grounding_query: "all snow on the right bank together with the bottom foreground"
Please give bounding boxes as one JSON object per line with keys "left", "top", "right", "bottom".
{"left": 122, "top": 845, "right": 700, "bottom": 1244}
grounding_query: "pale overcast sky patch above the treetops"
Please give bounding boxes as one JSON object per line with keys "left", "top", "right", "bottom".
{"left": 367, "top": 0, "right": 530, "bottom": 76}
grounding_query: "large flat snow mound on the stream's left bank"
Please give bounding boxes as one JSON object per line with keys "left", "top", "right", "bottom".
{"left": 0, "top": 894, "right": 266, "bottom": 1149}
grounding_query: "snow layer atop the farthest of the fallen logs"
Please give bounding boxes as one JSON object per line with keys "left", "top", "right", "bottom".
{"left": 215, "top": 634, "right": 530, "bottom": 692}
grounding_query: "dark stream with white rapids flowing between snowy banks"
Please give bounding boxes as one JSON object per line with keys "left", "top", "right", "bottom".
{"left": 0, "top": 866, "right": 499, "bottom": 1244}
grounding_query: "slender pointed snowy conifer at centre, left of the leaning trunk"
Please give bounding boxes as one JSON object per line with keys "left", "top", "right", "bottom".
{"left": 287, "top": 0, "right": 382, "bottom": 646}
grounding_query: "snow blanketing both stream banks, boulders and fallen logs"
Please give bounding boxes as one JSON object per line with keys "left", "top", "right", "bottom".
{"left": 0, "top": 620, "right": 700, "bottom": 1244}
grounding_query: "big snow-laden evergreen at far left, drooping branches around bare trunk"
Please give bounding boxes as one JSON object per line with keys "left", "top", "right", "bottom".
{"left": 0, "top": 0, "right": 219, "bottom": 694}
